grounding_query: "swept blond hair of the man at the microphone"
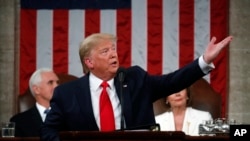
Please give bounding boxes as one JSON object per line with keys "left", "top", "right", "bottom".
{"left": 79, "top": 33, "right": 117, "bottom": 74}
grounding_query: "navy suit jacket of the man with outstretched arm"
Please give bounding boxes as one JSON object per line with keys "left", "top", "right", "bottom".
{"left": 41, "top": 59, "right": 204, "bottom": 140}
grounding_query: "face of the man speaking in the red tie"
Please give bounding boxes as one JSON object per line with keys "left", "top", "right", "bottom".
{"left": 88, "top": 41, "right": 119, "bottom": 80}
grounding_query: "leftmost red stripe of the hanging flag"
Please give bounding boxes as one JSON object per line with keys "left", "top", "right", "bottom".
{"left": 19, "top": 10, "right": 37, "bottom": 93}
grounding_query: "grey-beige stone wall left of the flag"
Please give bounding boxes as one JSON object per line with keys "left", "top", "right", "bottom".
{"left": 0, "top": 0, "right": 18, "bottom": 122}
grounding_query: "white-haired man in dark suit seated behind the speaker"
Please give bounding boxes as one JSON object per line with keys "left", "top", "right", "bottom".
{"left": 10, "top": 68, "right": 59, "bottom": 137}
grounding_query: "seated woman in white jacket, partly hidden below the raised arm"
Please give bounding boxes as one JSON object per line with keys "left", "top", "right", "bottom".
{"left": 155, "top": 88, "right": 212, "bottom": 136}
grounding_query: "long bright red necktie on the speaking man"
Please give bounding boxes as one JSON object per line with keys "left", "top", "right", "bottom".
{"left": 100, "top": 81, "right": 115, "bottom": 131}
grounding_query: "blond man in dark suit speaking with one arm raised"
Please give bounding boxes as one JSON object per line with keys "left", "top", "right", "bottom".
{"left": 41, "top": 33, "right": 232, "bottom": 141}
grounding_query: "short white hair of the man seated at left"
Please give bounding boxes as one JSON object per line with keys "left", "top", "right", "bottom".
{"left": 29, "top": 68, "right": 53, "bottom": 96}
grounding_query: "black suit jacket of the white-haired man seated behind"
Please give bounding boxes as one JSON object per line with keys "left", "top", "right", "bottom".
{"left": 10, "top": 105, "right": 43, "bottom": 137}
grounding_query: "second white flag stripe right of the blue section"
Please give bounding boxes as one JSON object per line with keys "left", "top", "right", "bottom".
{"left": 162, "top": 0, "right": 179, "bottom": 73}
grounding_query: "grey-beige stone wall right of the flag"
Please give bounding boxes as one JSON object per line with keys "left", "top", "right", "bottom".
{"left": 228, "top": 0, "right": 250, "bottom": 124}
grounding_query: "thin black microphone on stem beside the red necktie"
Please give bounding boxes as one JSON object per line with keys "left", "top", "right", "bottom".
{"left": 117, "top": 67, "right": 126, "bottom": 131}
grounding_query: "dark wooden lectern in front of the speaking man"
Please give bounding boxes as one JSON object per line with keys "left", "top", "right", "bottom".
{"left": 60, "top": 131, "right": 185, "bottom": 141}
